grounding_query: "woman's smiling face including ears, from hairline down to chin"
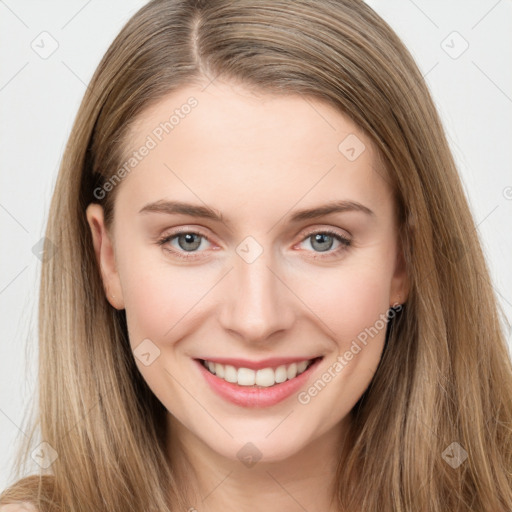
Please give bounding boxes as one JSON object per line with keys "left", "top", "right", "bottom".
{"left": 87, "top": 81, "right": 407, "bottom": 461}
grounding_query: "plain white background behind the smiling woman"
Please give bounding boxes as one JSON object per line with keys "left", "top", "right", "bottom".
{"left": 0, "top": 0, "right": 512, "bottom": 490}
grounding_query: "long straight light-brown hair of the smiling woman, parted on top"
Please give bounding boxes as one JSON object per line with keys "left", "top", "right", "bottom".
{"left": 0, "top": 0, "right": 512, "bottom": 512}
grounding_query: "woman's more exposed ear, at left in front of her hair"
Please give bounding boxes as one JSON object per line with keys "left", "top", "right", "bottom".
{"left": 86, "top": 203, "right": 124, "bottom": 309}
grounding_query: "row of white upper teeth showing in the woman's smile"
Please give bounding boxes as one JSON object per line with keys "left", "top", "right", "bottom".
{"left": 203, "top": 359, "right": 313, "bottom": 388}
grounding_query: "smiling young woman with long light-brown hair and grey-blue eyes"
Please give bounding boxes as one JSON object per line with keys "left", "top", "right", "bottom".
{"left": 0, "top": 0, "right": 512, "bottom": 512}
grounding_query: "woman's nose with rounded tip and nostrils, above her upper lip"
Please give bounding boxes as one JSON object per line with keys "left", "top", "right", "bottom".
{"left": 219, "top": 244, "right": 294, "bottom": 344}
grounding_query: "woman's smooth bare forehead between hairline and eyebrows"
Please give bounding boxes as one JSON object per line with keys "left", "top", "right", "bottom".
{"left": 113, "top": 81, "right": 391, "bottom": 224}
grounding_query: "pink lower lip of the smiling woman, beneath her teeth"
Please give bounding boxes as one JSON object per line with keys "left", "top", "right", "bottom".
{"left": 194, "top": 357, "right": 322, "bottom": 408}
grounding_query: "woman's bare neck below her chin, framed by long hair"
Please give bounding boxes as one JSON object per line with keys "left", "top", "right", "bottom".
{"left": 168, "top": 415, "right": 349, "bottom": 512}
